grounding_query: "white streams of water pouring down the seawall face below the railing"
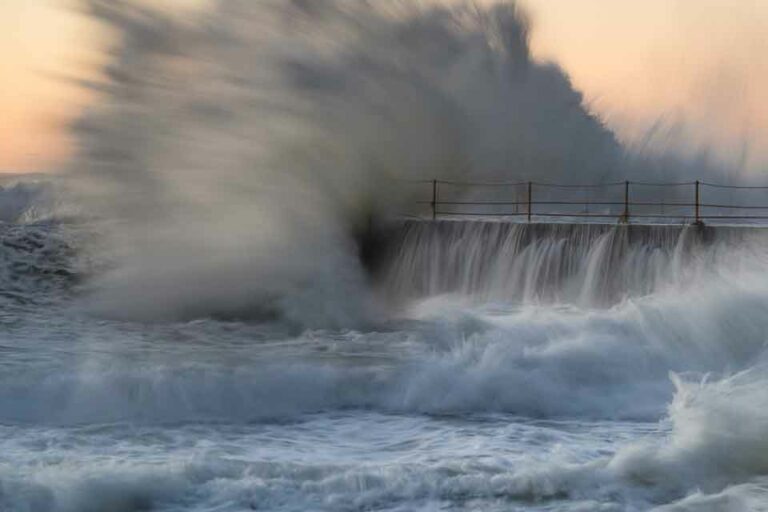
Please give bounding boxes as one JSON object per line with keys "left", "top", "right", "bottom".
{"left": 380, "top": 220, "right": 765, "bottom": 306}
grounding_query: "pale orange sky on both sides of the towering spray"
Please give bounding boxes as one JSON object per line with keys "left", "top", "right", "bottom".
{"left": 0, "top": 0, "right": 768, "bottom": 173}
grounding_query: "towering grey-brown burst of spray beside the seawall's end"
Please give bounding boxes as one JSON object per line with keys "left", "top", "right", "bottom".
{"left": 67, "top": 0, "right": 622, "bottom": 326}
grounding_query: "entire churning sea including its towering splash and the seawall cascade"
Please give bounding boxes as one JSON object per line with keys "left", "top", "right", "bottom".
{"left": 0, "top": 0, "right": 768, "bottom": 512}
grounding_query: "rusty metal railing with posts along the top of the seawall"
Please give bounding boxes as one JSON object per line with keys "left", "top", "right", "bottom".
{"left": 410, "top": 180, "right": 768, "bottom": 224}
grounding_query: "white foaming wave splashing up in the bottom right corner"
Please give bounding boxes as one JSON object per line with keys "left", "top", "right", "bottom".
{"left": 500, "top": 357, "right": 768, "bottom": 512}
